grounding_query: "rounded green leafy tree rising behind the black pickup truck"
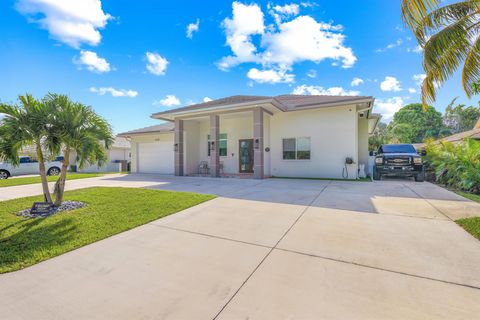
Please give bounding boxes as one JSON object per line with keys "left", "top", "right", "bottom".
{"left": 387, "top": 103, "right": 450, "bottom": 143}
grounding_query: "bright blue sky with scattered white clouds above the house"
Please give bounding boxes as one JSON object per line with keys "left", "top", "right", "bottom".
{"left": 0, "top": 0, "right": 478, "bottom": 133}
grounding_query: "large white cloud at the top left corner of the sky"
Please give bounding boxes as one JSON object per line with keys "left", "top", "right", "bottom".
{"left": 16, "top": 0, "right": 112, "bottom": 48}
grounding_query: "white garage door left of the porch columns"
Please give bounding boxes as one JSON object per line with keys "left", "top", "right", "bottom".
{"left": 138, "top": 141, "right": 175, "bottom": 174}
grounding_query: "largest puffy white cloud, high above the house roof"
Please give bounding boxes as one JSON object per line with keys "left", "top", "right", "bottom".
{"left": 218, "top": 2, "right": 357, "bottom": 82}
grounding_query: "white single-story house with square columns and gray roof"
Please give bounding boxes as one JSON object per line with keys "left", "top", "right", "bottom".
{"left": 119, "top": 95, "right": 380, "bottom": 179}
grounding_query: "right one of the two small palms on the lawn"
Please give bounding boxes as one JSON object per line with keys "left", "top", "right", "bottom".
{"left": 44, "top": 94, "right": 114, "bottom": 206}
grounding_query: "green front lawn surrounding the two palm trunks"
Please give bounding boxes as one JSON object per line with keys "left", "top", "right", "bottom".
{"left": 0, "top": 187, "right": 214, "bottom": 273}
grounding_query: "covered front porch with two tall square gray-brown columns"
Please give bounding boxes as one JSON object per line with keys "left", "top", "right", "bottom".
{"left": 174, "top": 107, "right": 271, "bottom": 179}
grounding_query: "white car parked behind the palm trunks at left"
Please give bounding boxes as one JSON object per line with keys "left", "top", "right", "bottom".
{"left": 0, "top": 157, "right": 63, "bottom": 179}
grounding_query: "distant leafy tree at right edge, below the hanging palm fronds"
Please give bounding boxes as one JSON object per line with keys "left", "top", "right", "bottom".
{"left": 443, "top": 98, "right": 480, "bottom": 133}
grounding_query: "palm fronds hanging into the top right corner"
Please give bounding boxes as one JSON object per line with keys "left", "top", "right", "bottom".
{"left": 401, "top": 0, "right": 480, "bottom": 108}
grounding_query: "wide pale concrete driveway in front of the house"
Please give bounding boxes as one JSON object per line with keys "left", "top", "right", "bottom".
{"left": 0, "top": 175, "right": 480, "bottom": 319}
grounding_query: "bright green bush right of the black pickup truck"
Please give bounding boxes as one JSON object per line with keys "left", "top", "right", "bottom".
{"left": 426, "top": 139, "right": 480, "bottom": 194}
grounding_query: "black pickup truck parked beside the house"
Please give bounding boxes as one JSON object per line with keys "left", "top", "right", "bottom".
{"left": 372, "top": 144, "right": 425, "bottom": 182}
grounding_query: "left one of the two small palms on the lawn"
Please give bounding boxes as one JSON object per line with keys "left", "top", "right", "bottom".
{"left": 0, "top": 94, "right": 53, "bottom": 203}
